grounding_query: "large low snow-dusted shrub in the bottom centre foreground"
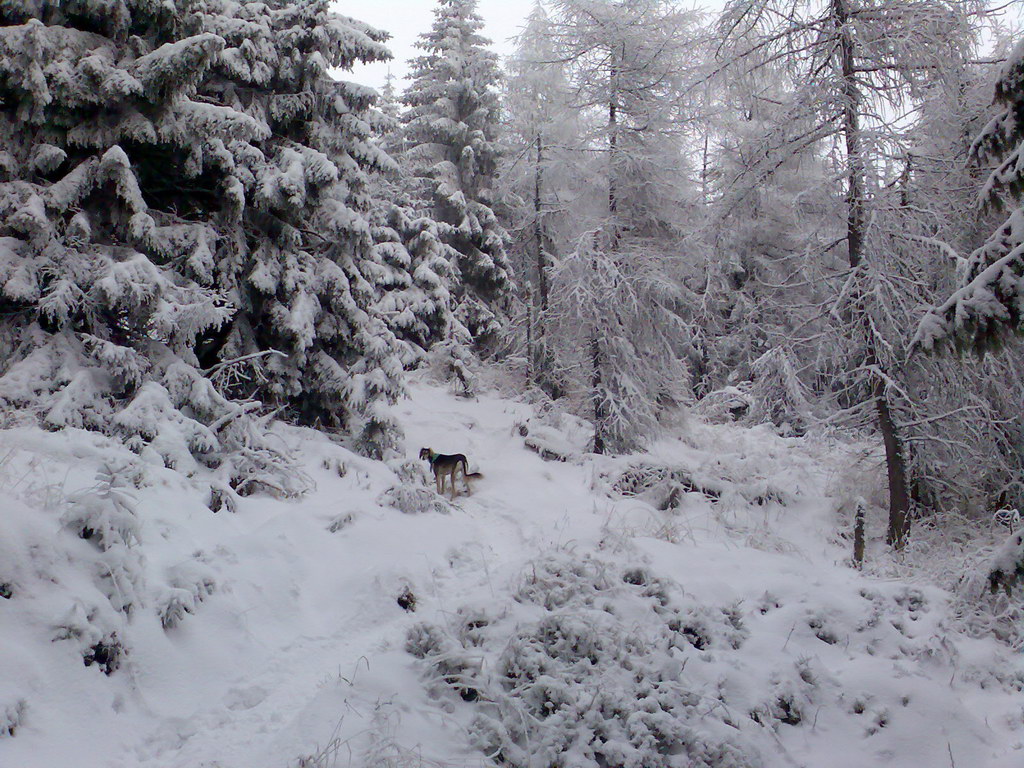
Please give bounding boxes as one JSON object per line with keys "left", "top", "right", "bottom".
{"left": 407, "top": 555, "right": 760, "bottom": 768}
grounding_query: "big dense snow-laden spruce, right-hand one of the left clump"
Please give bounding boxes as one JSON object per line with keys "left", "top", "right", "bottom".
{"left": 195, "top": 0, "right": 400, "bottom": 456}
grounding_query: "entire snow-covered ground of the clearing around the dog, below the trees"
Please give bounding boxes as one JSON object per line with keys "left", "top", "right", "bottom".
{"left": 0, "top": 380, "right": 1024, "bottom": 768}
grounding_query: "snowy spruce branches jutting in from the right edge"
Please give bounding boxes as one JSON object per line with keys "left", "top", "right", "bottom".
{"left": 914, "top": 41, "right": 1024, "bottom": 353}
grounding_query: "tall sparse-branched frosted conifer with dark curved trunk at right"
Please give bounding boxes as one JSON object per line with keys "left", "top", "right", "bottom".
{"left": 721, "top": 0, "right": 975, "bottom": 548}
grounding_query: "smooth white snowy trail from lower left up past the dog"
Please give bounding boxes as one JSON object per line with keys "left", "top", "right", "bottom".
{"left": 135, "top": 386, "right": 600, "bottom": 768}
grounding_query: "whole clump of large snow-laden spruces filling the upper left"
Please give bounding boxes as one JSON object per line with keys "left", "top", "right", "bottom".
{"left": 0, "top": 0, "right": 407, "bottom": 481}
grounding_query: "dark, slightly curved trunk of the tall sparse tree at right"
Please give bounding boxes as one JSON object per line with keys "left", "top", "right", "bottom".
{"left": 831, "top": 0, "right": 910, "bottom": 549}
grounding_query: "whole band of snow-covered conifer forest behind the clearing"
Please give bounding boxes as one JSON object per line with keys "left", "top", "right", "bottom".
{"left": 0, "top": 0, "right": 1024, "bottom": 547}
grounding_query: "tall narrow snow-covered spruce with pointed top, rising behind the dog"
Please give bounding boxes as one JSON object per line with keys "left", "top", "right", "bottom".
{"left": 402, "top": 0, "right": 513, "bottom": 344}
